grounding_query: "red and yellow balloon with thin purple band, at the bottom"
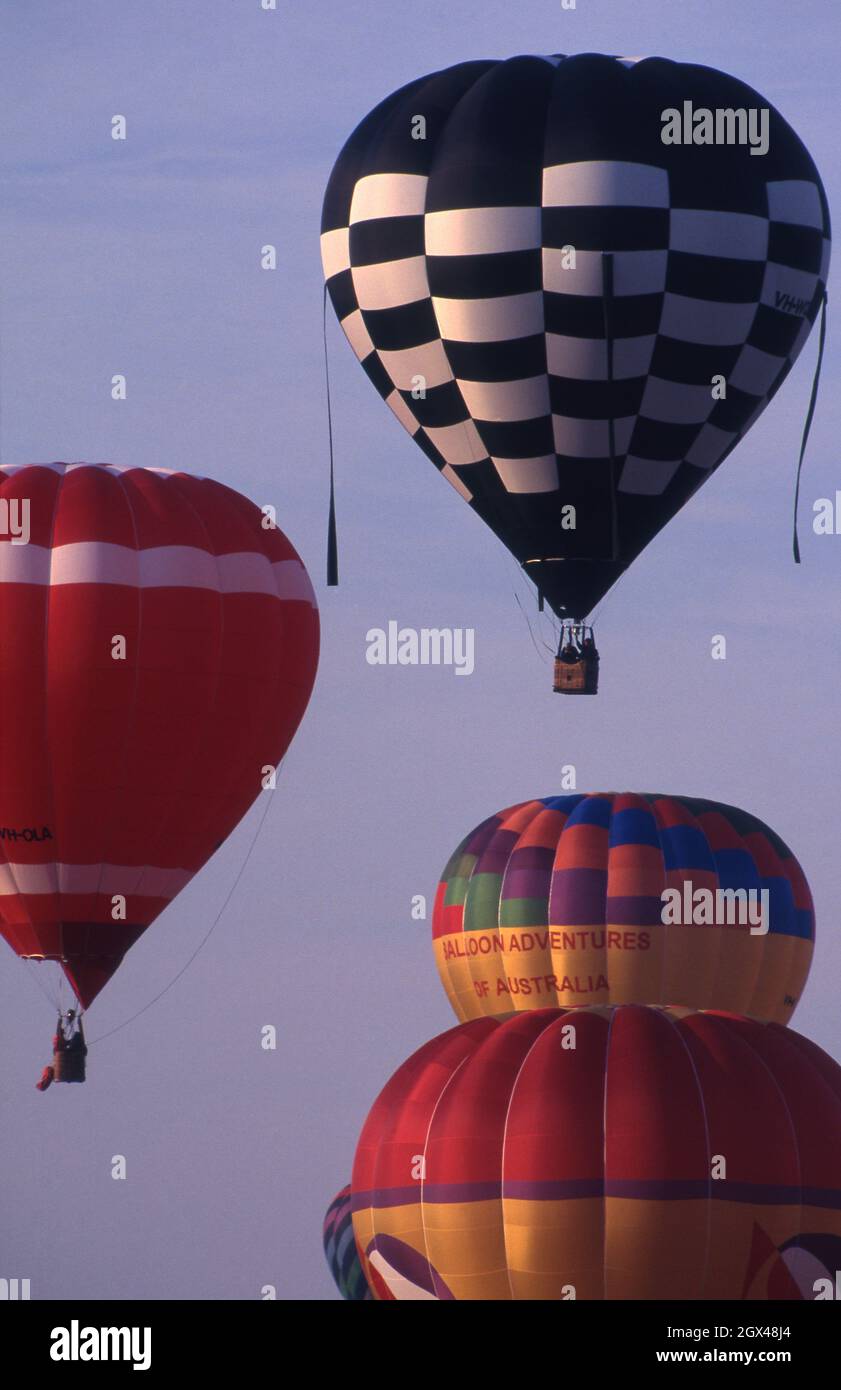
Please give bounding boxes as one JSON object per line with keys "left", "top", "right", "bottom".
{"left": 352, "top": 1005, "right": 841, "bottom": 1301}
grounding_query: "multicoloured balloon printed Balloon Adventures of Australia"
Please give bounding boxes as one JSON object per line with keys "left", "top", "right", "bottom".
{"left": 432, "top": 792, "right": 815, "bottom": 1023}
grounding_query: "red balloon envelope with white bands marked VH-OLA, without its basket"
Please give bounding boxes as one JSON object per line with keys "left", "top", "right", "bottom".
{"left": 0, "top": 463, "right": 318, "bottom": 1073}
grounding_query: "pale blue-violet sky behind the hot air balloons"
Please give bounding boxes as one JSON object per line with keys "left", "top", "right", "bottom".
{"left": 0, "top": 0, "right": 841, "bottom": 1298}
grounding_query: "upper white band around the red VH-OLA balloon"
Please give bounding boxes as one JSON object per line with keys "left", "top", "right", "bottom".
{"left": 0, "top": 541, "right": 300, "bottom": 594}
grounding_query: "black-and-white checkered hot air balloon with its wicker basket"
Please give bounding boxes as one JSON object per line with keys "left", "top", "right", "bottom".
{"left": 321, "top": 54, "right": 830, "bottom": 692}
